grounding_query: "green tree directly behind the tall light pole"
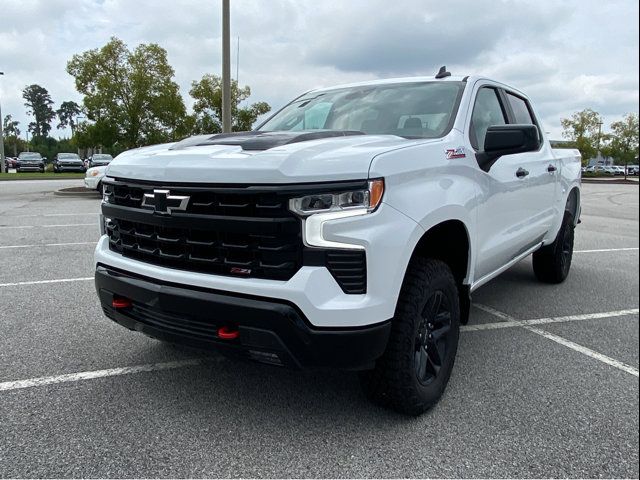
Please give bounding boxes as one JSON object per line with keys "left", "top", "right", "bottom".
{"left": 189, "top": 74, "right": 271, "bottom": 133}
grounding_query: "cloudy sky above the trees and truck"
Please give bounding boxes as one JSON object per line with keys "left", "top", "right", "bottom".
{"left": 0, "top": 0, "right": 638, "bottom": 138}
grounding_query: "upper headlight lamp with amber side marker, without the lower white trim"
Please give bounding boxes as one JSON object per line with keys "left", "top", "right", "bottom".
{"left": 289, "top": 179, "right": 384, "bottom": 217}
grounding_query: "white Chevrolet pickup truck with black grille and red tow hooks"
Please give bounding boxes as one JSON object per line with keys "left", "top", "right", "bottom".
{"left": 95, "top": 68, "right": 580, "bottom": 414}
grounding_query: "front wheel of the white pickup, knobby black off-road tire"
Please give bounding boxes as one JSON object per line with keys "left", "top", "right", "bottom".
{"left": 360, "top": 258, "right": 460, "bottom": 415}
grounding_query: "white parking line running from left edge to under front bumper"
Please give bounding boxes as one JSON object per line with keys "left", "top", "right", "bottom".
{"left": 0, "top": 358, "right": 203, "bottom": 392}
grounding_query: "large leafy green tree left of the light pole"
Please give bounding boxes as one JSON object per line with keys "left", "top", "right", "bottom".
{"left": 67, "top": 37, "right": 186, "bottom": 148}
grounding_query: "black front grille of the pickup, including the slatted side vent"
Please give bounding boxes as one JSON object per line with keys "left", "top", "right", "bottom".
{"left": 102, "top": 181, "right": 367, "bottom": 294}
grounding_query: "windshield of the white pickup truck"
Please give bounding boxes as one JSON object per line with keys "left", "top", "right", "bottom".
{"left": 258, "top": 82, "right": 464, "bottom": 138}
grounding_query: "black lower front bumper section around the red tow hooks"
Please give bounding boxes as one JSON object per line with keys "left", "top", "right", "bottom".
{"left": 95, "top": 264, "right": 391, "bottom": 370}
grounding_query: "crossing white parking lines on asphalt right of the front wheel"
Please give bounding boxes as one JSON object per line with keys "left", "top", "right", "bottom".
{"left": 460, "top": 303, "right": 640, "bottom": 377}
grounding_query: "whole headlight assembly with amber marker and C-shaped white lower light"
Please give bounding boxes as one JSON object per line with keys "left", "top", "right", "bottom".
{"left": 289, "top": 178, "right": 384, "bottom": 250}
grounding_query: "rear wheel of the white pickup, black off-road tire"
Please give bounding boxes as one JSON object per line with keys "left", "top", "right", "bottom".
{"left": 533, "top": 211, "right": 575, "bottom": 283}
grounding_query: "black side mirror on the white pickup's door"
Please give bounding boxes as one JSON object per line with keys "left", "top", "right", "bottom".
{"left": 476, "top": 125, "right": 540, "bottom": 172}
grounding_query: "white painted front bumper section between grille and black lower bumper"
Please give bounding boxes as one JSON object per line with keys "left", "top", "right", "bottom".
{"left": 95, "top": 203, "right": 423, "bottom": 328}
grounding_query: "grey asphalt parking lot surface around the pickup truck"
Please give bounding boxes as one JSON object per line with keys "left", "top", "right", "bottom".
{"left": 0, "top": 181, "right": 639, "bottom": 478}
